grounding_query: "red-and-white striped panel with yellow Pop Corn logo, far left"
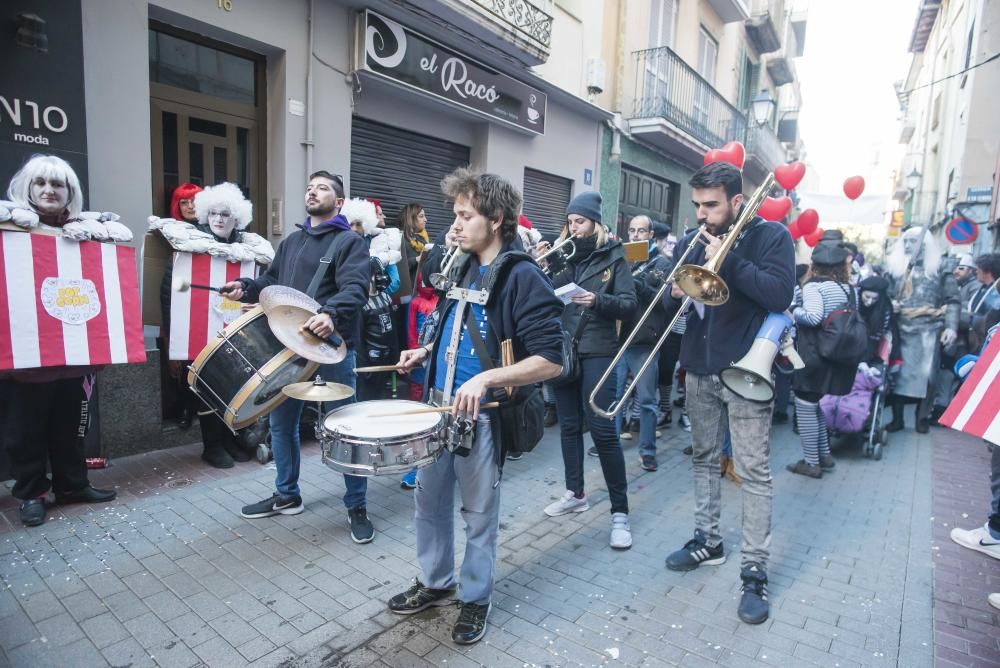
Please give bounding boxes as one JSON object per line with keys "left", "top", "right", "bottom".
{"left": 0, "top": 231, "right": 146, "bottom": 371}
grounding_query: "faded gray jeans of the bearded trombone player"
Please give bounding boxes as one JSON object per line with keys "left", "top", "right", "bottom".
{"left": 685, "top": 372, "right": 774, "bottom": 569}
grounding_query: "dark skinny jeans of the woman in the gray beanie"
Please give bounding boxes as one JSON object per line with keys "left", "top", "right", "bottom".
{"left": 555, "top": 357, "right": 628, "bottom": 513}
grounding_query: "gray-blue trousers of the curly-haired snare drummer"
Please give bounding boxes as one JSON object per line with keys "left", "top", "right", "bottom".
{"left": 414, "top": 417, "right": 500, "bottom": 604}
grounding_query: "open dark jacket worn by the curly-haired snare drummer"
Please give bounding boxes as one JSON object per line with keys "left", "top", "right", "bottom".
{"left": 424, "top": 244, "right": 562, "bottom": 470}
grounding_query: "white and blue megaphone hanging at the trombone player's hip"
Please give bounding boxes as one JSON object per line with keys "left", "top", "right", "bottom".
{"left": 719, "top": 313, "right": 805, "bottom": 403}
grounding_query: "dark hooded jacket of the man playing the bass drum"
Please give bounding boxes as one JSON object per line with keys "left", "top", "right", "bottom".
{"left": 240, "top": 225, "right": 371, "bottom": 350}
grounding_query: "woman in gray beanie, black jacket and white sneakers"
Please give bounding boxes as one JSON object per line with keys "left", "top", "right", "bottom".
{"left": 545, "top": 192, "right": 637, "bottom": 550}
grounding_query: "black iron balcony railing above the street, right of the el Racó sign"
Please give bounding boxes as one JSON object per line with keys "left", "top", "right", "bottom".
{"left": 632, "top": 46, "right": 746, "bottom": 148}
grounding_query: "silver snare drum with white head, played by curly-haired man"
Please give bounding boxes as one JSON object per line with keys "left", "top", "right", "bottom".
{"left": 321, "top": 399, "right": 448, "bottom": 477}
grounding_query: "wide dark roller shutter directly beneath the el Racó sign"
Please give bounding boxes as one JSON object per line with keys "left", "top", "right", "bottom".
{"left": 350, "top": 116, "right": 469, "bottom": 241}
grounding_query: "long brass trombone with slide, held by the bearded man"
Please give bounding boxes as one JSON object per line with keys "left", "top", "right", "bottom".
{"left": 589, "top": 174, "right": 774, "bottom": 418}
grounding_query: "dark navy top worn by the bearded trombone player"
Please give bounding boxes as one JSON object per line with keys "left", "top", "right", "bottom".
{"left": 670, "top": 218, "right": 795, "bottom": 376}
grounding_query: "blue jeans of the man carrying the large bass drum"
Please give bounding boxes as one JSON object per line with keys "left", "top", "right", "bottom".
{"left": 269, "top": 350, "right": 368, "bottom": 510}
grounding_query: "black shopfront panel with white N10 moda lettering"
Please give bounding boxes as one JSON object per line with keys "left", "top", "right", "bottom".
{"left": 0, "top": 0, "right": 89, "bottom": 196}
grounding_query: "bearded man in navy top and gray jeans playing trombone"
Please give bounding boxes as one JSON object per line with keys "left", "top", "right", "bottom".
{"left": 667, "top": 162, "right": 795, "bottom": 624}
